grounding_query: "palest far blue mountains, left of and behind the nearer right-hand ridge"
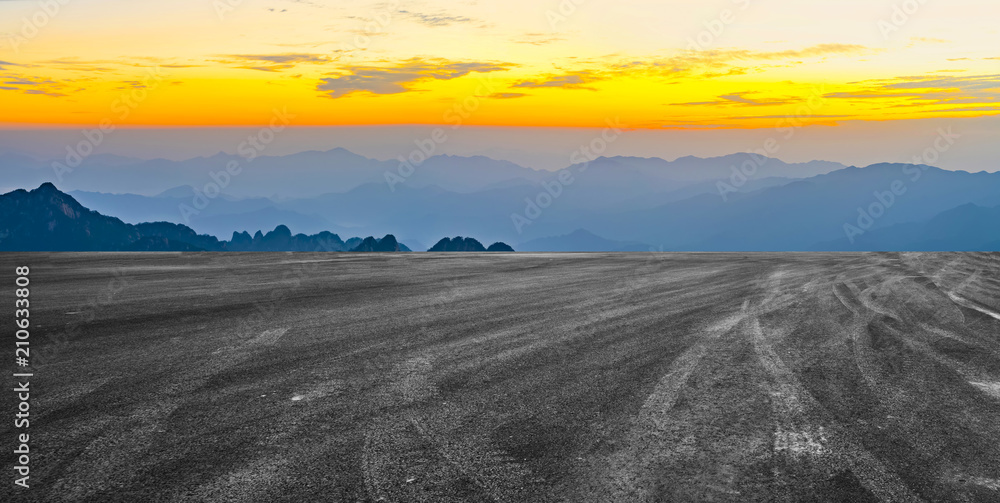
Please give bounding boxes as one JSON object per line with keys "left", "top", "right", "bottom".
{"left": 0, "top": 148, "right": 872, "bottom": 250}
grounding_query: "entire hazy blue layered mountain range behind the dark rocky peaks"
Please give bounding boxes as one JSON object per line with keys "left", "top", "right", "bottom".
{"left": 0, "top": 149, "right": 1000, "bottom": 251}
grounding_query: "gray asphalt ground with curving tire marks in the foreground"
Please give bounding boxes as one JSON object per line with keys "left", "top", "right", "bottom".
{"left": 0, "top": 254, "right": 1000, "bottom": 502}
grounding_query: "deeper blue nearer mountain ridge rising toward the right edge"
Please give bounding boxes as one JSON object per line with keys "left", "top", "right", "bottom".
{"left": 588, "top": 164, "right": 1000, "bottom": 251}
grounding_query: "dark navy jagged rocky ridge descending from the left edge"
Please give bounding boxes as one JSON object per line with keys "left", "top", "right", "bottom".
{"left": 0, "top": 183, "right": 409, "bottom": 252}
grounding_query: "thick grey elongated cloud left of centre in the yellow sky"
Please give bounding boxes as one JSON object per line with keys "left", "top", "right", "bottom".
{"left": 316, "top": 58, "right": 514, "bottom": 98}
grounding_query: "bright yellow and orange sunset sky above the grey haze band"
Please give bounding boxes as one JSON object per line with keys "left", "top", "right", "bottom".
{"left": 0, "top": 0, "right": 1000, "bottom": 169}
